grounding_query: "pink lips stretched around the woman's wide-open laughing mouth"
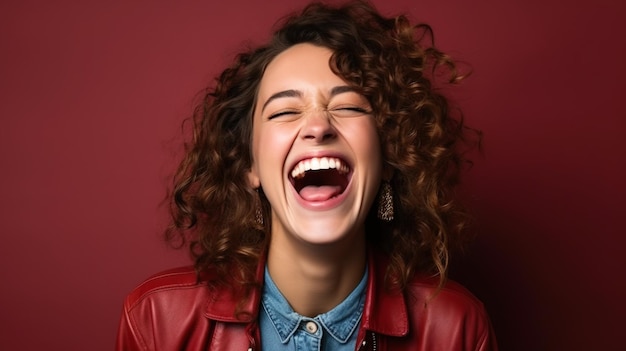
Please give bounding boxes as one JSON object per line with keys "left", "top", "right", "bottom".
{"left": 285, "top": 152, "right": 354, "bottom": 211}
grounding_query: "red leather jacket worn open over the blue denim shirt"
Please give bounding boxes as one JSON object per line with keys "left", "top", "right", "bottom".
{"left": 116, "top": 254, "right": 497, "bottom": 351}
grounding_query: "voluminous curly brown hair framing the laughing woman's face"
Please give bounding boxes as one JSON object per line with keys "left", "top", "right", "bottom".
{"left": 166, "top": 1, "right": 479, "bottom": 296}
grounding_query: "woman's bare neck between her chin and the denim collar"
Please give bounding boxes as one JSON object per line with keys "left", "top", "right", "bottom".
{"left": 267, "top": 235, "right": 366, "bottom": 317}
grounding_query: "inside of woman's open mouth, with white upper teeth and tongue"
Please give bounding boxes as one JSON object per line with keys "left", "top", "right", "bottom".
{"left": 289, "top": 157, "right": 351, "bottom": 201}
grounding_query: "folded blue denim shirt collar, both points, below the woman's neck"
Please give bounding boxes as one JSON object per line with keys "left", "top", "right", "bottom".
{"left": 261, "top": 268, "right": 368, "bottom": 343}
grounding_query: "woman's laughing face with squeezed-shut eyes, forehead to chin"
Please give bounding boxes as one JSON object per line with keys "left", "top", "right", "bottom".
{"left": 249, "top": 44, "right": 382, "bottom": 248}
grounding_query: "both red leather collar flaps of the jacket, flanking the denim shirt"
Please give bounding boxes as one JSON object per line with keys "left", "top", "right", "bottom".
{"left": 205, "top": 250, "right": 409, "bottom": 336}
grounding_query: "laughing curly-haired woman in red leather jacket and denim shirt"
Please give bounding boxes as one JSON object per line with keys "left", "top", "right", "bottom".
{"left": 118, "top": 2, "right": 496, "bottom": 350}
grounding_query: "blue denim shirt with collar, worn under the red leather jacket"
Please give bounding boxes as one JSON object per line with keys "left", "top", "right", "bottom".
{"left": 259, "top": 267, "right": 367, "bottom": 351}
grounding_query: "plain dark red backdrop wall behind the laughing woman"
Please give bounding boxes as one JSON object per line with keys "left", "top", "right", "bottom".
{"left": 0, "top": 0, "right": 626, "bottom": 350}
